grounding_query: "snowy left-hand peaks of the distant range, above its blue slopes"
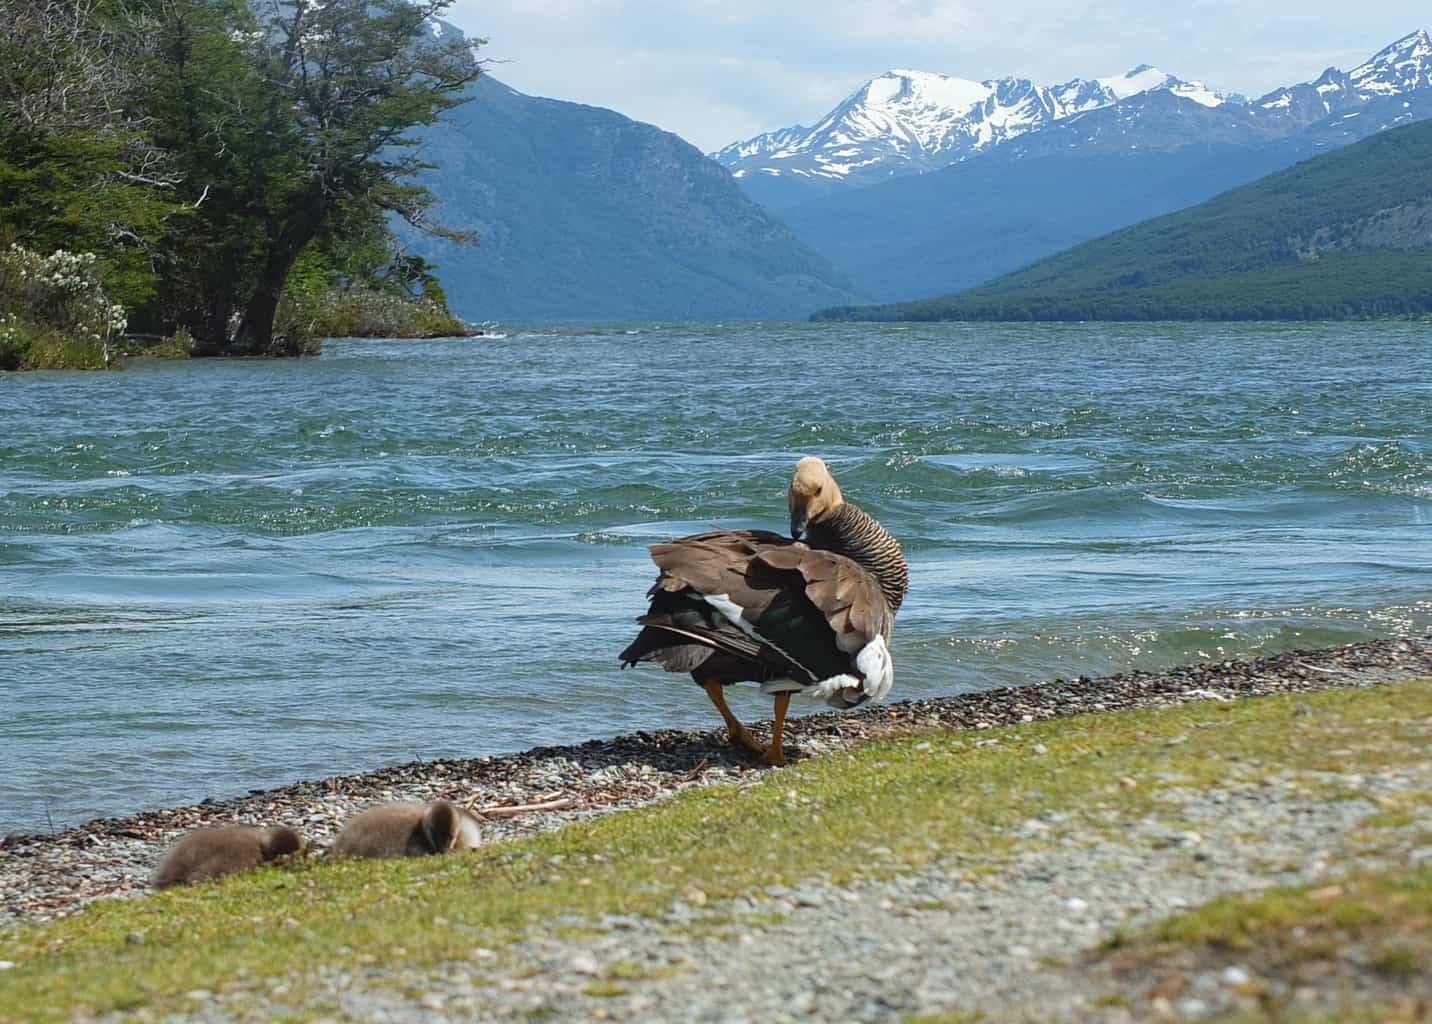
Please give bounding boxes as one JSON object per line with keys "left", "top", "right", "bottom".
{"left": 713, "top": 64, "right": 1227, "bottom": 183}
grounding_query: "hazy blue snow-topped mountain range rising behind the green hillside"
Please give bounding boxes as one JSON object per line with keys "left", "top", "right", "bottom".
{"left": 722, "top": 32, "right": 1432, "bottom": 302}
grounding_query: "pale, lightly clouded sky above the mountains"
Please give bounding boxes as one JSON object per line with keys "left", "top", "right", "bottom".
{"left": 444, "top": 0, "right": 1432, "bottom": 152}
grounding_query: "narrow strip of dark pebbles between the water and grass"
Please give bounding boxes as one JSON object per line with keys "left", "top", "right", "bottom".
{"left": 0, "top": 636, "right": 1432, "bottom": 924}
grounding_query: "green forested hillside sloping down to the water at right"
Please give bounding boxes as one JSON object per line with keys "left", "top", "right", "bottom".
{"left": 815, "top": 122, "right": 1432, "bottom": 321}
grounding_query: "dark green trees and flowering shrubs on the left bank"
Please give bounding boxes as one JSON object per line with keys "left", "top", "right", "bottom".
{"left": 0, "top": 0, "right": 478, "bottom": 368}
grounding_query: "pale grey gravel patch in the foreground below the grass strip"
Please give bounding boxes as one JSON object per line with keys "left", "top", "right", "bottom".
{"left": 296, "top": 762, "right": 1432, "bottom": 1024}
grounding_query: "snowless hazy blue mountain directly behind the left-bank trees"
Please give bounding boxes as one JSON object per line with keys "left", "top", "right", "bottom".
{"left": 404, "top": 76, "right": 866, "bottom": 321}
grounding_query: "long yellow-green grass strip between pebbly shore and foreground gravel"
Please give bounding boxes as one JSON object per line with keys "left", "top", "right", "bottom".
{"left": 0, "top": 680, "right": 1432, "bottom": 1020}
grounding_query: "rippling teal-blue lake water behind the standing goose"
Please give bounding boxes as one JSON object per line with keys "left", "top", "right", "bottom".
{"left": 0, "top": 324, "right": 1432, "bottom": 832}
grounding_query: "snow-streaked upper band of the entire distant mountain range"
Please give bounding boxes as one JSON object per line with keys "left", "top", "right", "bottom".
{"left": 712, "top": 32, "right": 1432, "bottom": 196}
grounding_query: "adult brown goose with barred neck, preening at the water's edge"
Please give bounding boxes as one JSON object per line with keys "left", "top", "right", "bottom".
{"left": 620, "top": 457, "right": 909, "bottom": 765}
